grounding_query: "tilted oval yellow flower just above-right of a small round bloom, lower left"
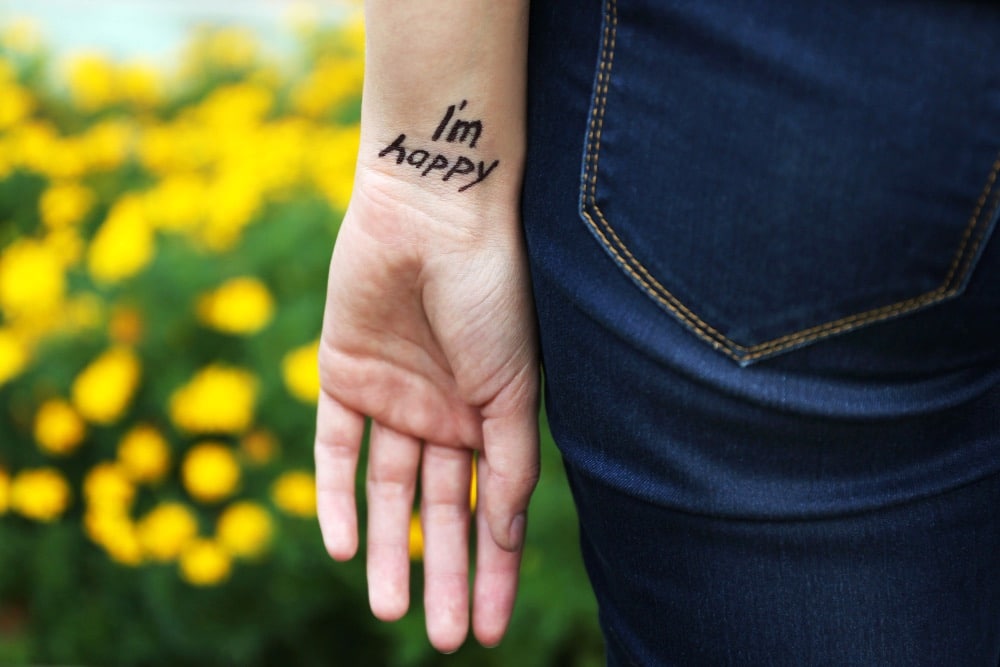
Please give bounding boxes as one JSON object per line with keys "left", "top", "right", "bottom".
{"left": 71, "top": 346, "right": 140, "bottom": 424}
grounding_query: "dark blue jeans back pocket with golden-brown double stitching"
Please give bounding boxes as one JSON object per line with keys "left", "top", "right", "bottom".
{"left": 580, "top": 0, "right": 1000, "bottom": 365}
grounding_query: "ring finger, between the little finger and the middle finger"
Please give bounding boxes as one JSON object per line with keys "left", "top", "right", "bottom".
{"left": 365, "top": 423, "right": 420, "bottom": 621}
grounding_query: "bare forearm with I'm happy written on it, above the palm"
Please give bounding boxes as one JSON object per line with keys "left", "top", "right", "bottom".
{"left": 359, "top": 0, "right": 528, "bottom": 209}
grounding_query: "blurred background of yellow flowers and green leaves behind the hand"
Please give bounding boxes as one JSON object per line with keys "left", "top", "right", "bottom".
{"left": 0, "top": 0, "right": 603, "bottom": 667}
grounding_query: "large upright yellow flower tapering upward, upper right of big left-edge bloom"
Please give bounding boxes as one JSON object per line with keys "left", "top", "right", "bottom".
{"left": 87, "top": 195, "right": 154, "bottom": 283}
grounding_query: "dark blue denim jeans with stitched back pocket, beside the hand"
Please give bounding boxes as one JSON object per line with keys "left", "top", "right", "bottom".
{"left": 524, "top": 0, "right": 1000, "bottom": 665}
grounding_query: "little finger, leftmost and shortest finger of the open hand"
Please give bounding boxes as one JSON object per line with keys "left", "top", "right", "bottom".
{"left": 313, "top": 391, "right": 365, "bottom": 560}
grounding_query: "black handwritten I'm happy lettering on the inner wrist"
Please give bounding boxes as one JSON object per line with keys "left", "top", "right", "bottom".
{"left": 378, "top": 100, "right": 500, "bottom": 192}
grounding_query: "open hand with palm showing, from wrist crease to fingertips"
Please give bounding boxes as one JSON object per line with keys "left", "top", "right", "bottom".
{"left": 315, "top": 171, "right": 538, "bottom": 652}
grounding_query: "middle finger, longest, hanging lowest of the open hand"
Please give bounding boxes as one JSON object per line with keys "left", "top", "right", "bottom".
{"left": 420, "top": 444, "right": 472, "bottom": 653}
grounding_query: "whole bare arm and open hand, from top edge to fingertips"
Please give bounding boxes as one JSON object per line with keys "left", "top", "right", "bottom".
{"left": 315, "top": 0, "right": 538, "bottom": 651}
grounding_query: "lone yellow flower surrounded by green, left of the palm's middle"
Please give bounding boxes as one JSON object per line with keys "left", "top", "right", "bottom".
{"left": 198, "top": 276, "right": 274, "bottom": 334}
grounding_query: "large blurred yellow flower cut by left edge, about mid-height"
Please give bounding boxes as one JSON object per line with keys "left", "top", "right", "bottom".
{"left": 0, "top": 238, "right": 66, "bottom": 317}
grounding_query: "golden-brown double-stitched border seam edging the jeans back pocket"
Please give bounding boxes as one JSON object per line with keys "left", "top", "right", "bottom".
{"left": 580, "top": 0, "right": 1000, "bottom": 365}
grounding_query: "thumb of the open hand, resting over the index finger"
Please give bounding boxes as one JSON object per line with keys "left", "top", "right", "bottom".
{"left": 479, "top": 401, "right": 538, "bottom": 551}
